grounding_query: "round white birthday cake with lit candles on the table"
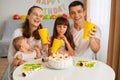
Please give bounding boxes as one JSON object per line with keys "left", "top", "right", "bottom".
{"left": 48, "top": 54, "right": 73, "bottom": 69}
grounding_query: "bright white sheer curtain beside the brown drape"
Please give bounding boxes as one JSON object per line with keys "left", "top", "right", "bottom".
{"left": 90, "top": 0, "right": 111, "bottom": 62}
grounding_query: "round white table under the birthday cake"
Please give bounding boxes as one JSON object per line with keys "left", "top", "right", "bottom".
{"left": 13, "top": 57, "right": 115, "bottom": 80}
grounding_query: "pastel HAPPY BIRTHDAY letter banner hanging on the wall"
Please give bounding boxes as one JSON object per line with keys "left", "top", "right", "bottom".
{"left": 36, "top": 0, "right": 83, "bottom": 15}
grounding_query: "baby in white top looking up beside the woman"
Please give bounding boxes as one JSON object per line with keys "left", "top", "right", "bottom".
{"left": 13, "top": 36, "right": 41, "bottom": 66}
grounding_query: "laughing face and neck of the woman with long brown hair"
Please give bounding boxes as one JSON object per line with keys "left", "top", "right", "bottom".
{"left": 27, "top": 8, "right": 43, "bottom": 31}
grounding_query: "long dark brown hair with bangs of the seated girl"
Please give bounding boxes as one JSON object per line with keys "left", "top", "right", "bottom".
{"left": 51, "top": 17, "right": 75, "bottom": 50}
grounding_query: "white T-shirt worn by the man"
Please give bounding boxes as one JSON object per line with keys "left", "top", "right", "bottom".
{"left": 71, "top": 24, "right": 101, "bottom": 59}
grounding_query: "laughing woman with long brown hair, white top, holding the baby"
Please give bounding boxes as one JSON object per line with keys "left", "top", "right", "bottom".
{"left": 5, "top": 6, "right": 46, "bottom": 78}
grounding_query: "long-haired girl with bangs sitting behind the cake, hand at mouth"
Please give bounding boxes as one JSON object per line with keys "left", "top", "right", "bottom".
{"left": 50, "top": 15, "right": 75, "bottom": 55}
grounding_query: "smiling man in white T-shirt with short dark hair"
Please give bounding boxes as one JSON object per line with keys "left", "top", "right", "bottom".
{"left": 69, "top": 1, "right": 101, "bottom": 59}
